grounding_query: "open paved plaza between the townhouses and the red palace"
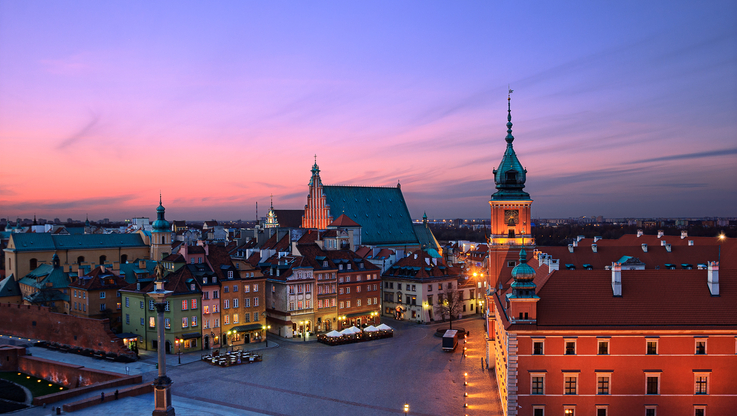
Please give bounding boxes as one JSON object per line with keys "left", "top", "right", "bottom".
{"left": 7, "top": 319, "right": 502, "bottom": 416}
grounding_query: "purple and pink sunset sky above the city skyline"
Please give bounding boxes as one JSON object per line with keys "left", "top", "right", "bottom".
{"left": 0, "top": 0, "right": 737, "bottom": 220}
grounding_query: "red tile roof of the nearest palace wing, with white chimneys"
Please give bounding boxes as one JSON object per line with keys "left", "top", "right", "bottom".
{"left": 495, "top": 270, "right": 737, "bottom": 329}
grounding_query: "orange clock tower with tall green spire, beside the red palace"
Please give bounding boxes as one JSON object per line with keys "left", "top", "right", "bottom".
{"left": 489, "top": 90, "right": 535, "bottom": 288}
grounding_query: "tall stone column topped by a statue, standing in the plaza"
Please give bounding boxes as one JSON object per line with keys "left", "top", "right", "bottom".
{"left": 148, "top": 263, "right": 174, "bottom": 416}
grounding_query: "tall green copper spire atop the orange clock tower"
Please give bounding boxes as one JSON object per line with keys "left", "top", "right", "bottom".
{"left": 491, "top": 98, "right": 530, "bottom": 200}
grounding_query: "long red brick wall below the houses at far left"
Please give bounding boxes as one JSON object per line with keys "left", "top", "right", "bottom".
{"left": 0, "top": 303, "right": 131, "bottom": 354}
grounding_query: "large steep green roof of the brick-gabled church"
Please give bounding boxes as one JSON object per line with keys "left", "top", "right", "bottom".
{"left": 323, "top": 185, "right": 418, "bottom": 245}
